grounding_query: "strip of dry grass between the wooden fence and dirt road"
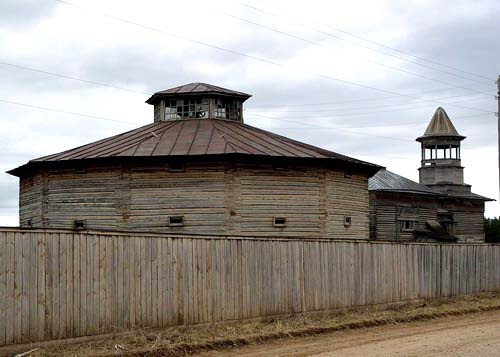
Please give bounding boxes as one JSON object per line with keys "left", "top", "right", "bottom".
{"left": 0, "top": 294, "right": 500, "bottom": 357}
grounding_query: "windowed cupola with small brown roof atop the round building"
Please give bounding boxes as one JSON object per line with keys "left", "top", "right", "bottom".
{"left": 146, "top": 83, "right": 251, "bottom": 123}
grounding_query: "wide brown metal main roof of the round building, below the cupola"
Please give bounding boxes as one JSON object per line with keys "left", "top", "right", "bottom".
{"left": 9, "top": 119, "right": 380, "bottom": 175}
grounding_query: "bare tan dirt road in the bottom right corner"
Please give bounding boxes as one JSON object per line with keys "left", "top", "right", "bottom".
{"left": 199, "top": 311, "right": 500, "bottom": 357}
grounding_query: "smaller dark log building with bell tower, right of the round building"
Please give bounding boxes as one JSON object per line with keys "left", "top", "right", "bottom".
{"left": 369, "top": 107, "right": 491, "bottom": 243}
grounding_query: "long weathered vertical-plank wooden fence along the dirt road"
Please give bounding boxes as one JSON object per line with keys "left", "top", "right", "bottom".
{"left": 0, "top": 229, "right": 500, "bottom": 346}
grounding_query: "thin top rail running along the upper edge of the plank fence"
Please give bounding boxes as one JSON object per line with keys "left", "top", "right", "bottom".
{"left": 0, "top": 226, "right": 500, "bottom": 247}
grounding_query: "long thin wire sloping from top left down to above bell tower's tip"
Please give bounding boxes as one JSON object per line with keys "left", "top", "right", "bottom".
{"left": 50, "top": 0, "right": 492, "bottom": 114}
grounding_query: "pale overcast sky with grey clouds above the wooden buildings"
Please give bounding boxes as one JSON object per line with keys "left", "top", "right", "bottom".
{"left": 0, "top": 0, "right": 500, "bottom": 226}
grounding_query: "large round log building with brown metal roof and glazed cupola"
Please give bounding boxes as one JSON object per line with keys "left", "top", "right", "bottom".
{"left": 9, "top": 83, "right": 380, "bottom": 239}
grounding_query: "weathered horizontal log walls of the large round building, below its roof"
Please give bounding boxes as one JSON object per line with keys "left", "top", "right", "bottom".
{"left": 21, "top": 162, "right": 369, "bottom": 239}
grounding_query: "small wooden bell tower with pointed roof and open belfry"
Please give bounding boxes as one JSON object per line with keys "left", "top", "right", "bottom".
{"left": 416, "top": 107, "right": 471, "bottom": 193}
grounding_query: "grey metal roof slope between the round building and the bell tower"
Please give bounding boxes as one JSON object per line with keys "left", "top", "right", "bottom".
{"left": 368, "top": 169, "right": 441, "bottom": 196}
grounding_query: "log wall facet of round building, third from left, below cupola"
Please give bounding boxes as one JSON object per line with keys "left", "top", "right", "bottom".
{"left": 126, "top": 163, "right": 226, "bottom": 234}
